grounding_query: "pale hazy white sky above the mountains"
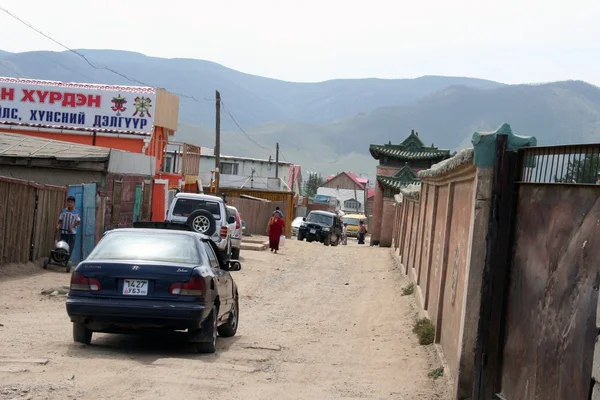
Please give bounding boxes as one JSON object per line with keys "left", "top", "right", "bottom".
{"left": 0, "top": 0, "right": 600, "bottom": 85}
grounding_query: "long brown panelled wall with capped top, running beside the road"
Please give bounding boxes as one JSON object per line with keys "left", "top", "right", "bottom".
{"left": 390, "top": 149, "right": 491, "bottom": 399}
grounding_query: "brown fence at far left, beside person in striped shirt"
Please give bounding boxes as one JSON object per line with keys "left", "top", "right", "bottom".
{"left": 0, "top": 176, "right": 66, "bottom": 266}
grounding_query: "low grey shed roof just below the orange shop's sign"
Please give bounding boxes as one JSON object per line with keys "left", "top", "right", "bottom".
{"left": 0, "top": 132, "right": 110, "bottom": 160}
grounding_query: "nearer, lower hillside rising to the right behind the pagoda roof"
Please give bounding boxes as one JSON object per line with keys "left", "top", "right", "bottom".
{"left": 172, "top": 81, "right": 600, "bottom": 173}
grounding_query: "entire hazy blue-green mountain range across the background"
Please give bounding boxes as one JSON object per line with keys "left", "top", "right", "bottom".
{"left": 0, "top": 50, "right": 600, "bottom": 175}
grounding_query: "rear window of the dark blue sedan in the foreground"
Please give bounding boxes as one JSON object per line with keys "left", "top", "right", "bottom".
{"left": 87, "top": 231, "right": 201, "bottom": 264}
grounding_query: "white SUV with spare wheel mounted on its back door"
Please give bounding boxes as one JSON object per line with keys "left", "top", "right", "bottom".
{"left": 167, "top": 193, "right": 235, "bottom": 260}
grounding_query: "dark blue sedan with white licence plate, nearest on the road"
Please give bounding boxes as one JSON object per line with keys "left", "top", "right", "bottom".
{"left": 66, "top": 223, "right": 241, "bottom": 353}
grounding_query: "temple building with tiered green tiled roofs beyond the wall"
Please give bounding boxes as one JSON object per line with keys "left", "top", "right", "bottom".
{"left": 369, "top": 130, "right": 451, "bottom": 247}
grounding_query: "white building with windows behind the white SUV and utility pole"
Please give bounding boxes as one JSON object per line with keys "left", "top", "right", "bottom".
{"left": 200, "top": 155, "right": 289, "bottom": 190}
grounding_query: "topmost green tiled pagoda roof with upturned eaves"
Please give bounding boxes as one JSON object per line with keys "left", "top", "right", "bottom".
{"left": 369, "top": 131, "right": 450, "bottom": 160}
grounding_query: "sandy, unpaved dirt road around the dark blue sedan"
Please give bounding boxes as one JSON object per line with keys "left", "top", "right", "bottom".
{"left": 0, "top": 236, "right": 448, "bottom": 400}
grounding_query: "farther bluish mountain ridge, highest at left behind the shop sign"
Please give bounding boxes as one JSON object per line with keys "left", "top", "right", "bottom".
{"left": 0, "top": 50, "right": 502, "bottom": 128}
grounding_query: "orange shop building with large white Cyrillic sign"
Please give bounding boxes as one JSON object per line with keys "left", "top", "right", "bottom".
{"left": 0, "top": 77, "right": 199, "bottom": 220}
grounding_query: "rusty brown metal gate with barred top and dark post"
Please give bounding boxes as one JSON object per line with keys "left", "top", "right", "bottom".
{"left": 473, "top": 136, "right": 600, "bottom": 400}
